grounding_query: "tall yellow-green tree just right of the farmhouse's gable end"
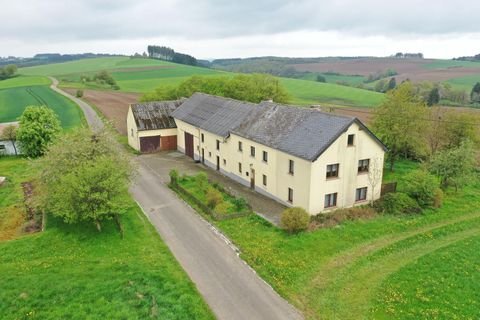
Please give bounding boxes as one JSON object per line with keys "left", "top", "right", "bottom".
{"left": 372, "top": 82, "right": 427, "bottom": 171}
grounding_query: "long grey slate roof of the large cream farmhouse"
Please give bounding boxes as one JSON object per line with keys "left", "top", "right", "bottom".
{"left": 172, "top": 93, "right": 384, "bottom": 161}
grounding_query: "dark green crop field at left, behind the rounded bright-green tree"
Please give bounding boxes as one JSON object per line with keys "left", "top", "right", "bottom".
{"left": 0, "top": 86, "right": 84, "bottom": 128}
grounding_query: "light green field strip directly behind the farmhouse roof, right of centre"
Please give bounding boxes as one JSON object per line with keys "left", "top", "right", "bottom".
{"left": 280, "top": 78, "right": 384, "bottom": 107}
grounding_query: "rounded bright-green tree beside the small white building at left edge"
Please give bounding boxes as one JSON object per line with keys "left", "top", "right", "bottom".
{"left": 17, "top": 106, "right": 61, "bottom": 158}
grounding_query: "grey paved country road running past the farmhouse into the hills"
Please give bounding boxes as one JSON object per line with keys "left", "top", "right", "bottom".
{"left": 52, "top": 78, "right": 302, "bottom": 320}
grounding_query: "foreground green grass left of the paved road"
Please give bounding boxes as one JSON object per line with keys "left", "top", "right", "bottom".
{"left": 0, "top": 158, "right": 214, "bottom": 319}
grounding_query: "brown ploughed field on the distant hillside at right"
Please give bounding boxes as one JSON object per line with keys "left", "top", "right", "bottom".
{"left": 289, "top": 58, "right": 480, "bottom": 82}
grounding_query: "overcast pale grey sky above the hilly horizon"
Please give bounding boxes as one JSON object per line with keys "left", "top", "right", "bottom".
{"left": 0, "top": 0, "right": 480, "bottom": 59}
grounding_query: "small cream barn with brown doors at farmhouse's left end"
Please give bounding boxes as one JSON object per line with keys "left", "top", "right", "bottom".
{"left": 127, "top": 100, "right": 184, "bottom": 153}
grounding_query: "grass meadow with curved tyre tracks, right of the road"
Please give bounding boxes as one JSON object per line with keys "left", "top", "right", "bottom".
{"left": 217, "top": 161, "right": 480, "bottom": 319}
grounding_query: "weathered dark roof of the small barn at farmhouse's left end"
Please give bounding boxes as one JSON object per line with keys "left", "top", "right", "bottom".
{"left": 130, "top": 99, "right": 185, "bottom": 131}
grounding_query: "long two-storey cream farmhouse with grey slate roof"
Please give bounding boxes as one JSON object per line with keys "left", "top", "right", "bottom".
{"left": 128, "top": 93, "right": 385, "bottom": 214}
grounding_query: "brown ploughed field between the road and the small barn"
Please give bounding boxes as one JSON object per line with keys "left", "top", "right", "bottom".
{"left": 65, "top": 89, "right": 140, "bottom": 135}
